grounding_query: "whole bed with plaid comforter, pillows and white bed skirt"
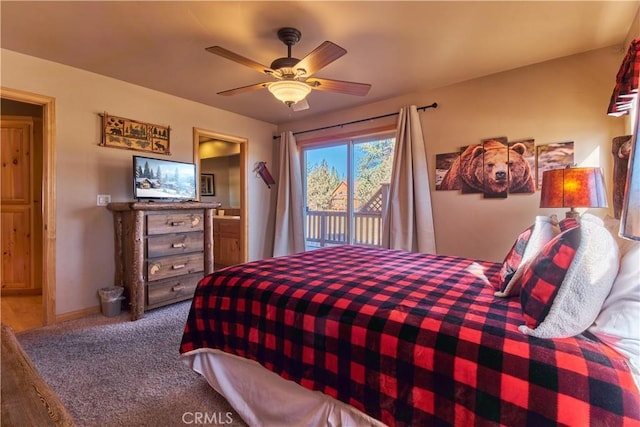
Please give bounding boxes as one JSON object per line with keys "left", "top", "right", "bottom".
{"left": 180, "top": 137, "right": 640, "bottom": 426}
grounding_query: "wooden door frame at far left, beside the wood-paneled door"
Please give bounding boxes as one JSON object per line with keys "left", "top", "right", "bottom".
{"left": 0, "top": 87, "right": 56, "bottom": 325}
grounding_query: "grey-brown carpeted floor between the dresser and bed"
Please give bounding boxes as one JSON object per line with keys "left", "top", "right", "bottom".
{"left": 17, "top": 302, "right": 246, "bottom": 427}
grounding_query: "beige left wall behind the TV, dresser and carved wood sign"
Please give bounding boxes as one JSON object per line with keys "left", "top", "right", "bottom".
{"left": 0, "top": 49, "right": 275, "bottom": 315}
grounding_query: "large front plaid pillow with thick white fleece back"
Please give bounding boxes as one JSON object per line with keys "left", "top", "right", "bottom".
{"left": 519, "top": 214, "right": 619, "bottom": 338}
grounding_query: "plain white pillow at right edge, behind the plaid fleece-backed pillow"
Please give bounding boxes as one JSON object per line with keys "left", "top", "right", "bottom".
{"left": 589, "top": 241, "right": 640, "bottom": 388}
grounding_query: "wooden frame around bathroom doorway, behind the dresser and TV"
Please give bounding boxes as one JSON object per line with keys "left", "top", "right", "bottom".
{"left": 193, "top": 127, "right": 249, "bottom": 262}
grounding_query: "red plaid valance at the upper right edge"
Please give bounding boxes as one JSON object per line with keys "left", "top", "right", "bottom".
{"left": 607, "top": 38, "right": 640, "bottom": 117}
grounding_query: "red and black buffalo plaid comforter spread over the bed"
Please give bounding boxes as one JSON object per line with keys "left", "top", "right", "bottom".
{"left": 180, "top": 246, "right": 640, "bottom": 426}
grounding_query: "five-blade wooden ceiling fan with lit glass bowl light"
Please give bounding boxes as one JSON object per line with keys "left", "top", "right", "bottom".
{"left": 206, "top": 27, "right": 371, "bottom": 109}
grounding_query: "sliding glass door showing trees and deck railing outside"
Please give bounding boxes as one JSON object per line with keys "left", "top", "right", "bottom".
{"left": 303, "top": 135, "right": 395, "bottom": 250}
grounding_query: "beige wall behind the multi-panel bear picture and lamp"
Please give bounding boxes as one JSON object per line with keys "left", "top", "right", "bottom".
{"left": 279, "top": 48, "right": 625, "bottom": 261}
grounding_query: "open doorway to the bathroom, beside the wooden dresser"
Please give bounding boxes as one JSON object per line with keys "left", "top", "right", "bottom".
{"left": 193, "top": 128, "right": 248, "bottom": 267}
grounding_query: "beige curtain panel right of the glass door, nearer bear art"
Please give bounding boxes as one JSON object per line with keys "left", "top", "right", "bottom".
{"left": 382, "top": 105, "right": 436, "bottom": 253}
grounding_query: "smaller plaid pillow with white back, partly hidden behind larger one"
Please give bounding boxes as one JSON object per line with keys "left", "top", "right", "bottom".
{"left": 495, "top": 216, "right": 557, "bottom": 297}
